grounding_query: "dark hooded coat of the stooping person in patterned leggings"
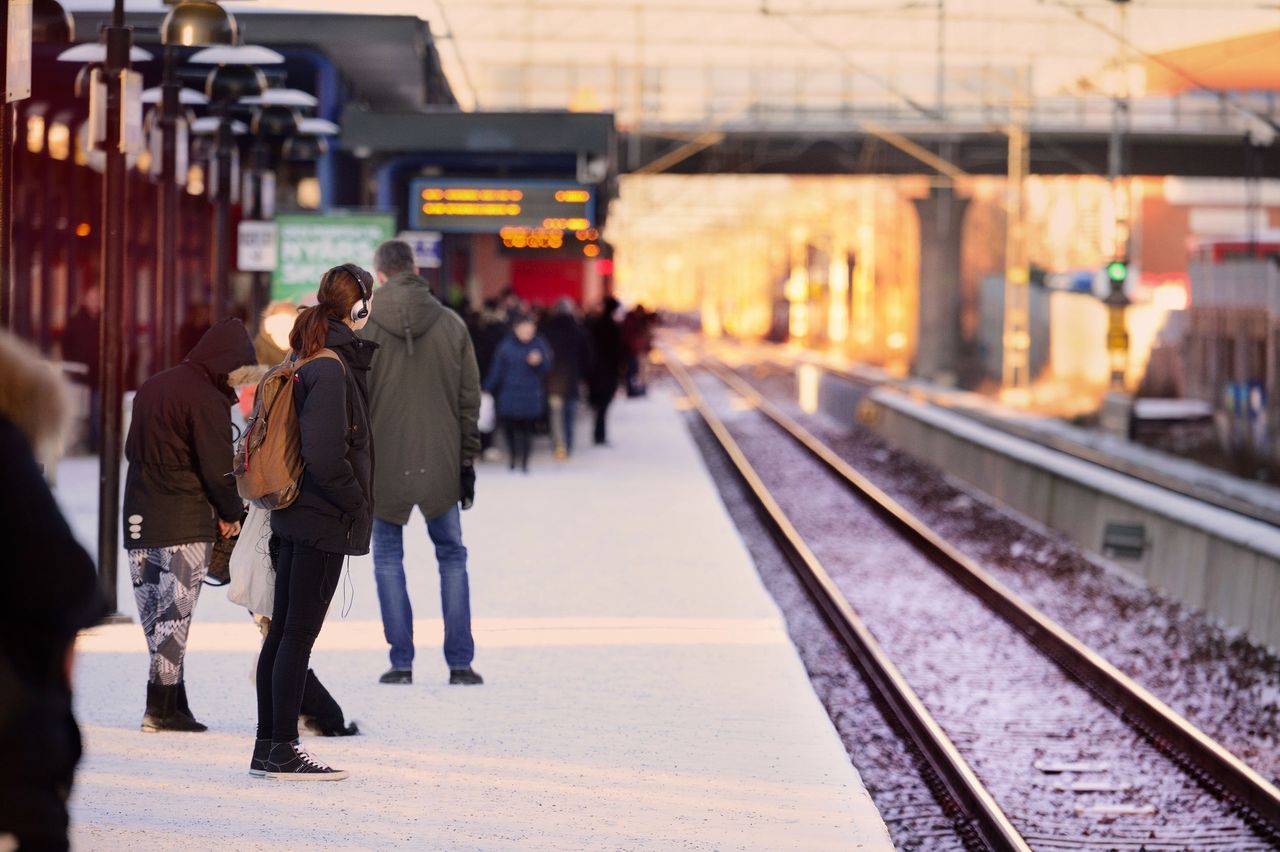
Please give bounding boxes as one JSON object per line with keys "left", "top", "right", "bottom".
{"left": 124, "top": 320, "right": 257, "bottom": 550}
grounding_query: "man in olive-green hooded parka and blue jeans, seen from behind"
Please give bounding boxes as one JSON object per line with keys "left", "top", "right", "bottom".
{"left": 362, "top": 239, "right": 484, "bottom": 686}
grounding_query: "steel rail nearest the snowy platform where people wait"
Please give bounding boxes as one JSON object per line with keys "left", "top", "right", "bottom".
{"left": 664, "top": 351, "right": 1030, "bottom": 852}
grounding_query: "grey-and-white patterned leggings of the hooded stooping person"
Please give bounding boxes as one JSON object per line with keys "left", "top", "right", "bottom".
{"left": 129, "top": 541, "right": 214, "bottom": 686}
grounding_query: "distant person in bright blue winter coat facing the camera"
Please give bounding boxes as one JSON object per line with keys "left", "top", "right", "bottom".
{"left": 484, "top": 316, "right": 552, "bottom": 473}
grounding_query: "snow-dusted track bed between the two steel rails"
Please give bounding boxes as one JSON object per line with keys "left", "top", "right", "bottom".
{"left": 700, "top": 370, "right": 1266, "bottom": 849}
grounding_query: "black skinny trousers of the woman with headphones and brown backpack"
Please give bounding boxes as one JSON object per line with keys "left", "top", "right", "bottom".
{"left": 257, "top": 539, "right": 346, "bottom": 742}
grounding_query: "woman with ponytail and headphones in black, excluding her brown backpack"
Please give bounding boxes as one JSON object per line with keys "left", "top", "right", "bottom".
{"left": 250, "top": 264, "right": 378, "bottom": 780}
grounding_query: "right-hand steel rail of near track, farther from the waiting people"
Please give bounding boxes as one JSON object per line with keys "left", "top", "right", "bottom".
{"left": 704, "top": 358, "right": 1280, "bottom": 839}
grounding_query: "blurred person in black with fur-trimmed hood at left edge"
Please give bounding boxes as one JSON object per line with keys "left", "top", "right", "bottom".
{"left": 0, "top": 331, "right": 105, "bottom": 849}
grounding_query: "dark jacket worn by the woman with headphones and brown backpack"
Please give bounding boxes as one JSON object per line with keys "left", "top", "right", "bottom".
{"left": 271, "top": 320, "right": 378, "bottom": 556}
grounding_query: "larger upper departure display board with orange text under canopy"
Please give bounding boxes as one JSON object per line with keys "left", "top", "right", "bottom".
{"left": 410, "top": 178, "right": 595, "bottom": 234}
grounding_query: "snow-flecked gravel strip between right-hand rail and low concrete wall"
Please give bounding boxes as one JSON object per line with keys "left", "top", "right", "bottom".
{"left": 742, "top": 372, "right": 1280, "bottom": 783}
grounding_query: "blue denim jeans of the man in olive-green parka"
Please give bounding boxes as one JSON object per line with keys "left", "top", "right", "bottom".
{"left": 372, "top": 505, "right": 475, "bottom": 669}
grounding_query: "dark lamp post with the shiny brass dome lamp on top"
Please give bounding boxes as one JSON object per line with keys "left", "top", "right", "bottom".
{"left": 154, "top": 0, "right": 239, "bottom": 368}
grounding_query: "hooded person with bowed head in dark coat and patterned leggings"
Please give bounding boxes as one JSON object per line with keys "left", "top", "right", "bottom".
{"left": 123, "top": 320, "right": 256, "bottom": 732}
